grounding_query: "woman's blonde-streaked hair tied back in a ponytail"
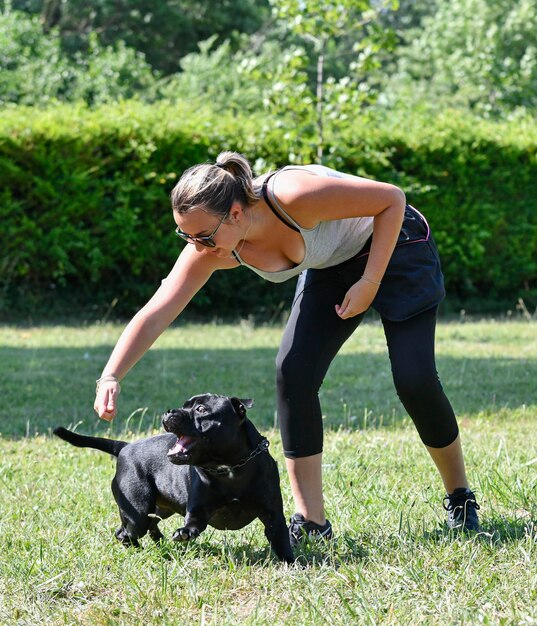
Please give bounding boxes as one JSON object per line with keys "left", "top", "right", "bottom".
{"left": 171, "top": 151, "right": 261, "bottom": 216}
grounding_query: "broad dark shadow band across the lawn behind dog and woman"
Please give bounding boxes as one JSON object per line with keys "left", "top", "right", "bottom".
{"left": 0, "top": 345, "right": 537, "bottom": 439}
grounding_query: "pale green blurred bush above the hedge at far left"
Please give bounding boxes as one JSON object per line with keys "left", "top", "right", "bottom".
{"left": 0, "top": 11, "right": 155, "bottom": 106}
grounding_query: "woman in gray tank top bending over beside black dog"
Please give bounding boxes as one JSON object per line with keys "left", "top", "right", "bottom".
{"left": 95, "top": 152, "right": 479, "bottom": 544}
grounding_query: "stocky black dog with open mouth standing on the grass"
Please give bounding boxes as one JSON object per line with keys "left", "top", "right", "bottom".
{"left": 54, "top": 394, "right": 294, "bottom": 563}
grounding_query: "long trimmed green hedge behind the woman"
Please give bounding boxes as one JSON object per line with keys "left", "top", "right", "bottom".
{"left": 0, "top": 103, "right": 537, "bottom": 318}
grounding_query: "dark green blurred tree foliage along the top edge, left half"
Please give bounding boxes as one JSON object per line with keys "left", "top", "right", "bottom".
{"left": 4, "top": 0, "right": 268, "bottom": 74}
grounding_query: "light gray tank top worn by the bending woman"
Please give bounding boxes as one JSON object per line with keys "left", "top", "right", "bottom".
{"left": 233, "top": 165, "right": 373, "bottom": 283}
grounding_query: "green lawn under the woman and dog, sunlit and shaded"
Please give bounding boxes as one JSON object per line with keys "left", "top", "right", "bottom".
{"left": 0, "top": 321, "right": 537, "bottom": 626}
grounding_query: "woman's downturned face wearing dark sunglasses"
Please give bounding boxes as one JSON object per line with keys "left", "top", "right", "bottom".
{"left": 174, "top": 204, "right": 242, "bottom": 257}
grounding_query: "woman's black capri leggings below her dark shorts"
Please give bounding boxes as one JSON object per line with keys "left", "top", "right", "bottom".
{"left": 276, "top": 251, "right": 459, "bottom": 458}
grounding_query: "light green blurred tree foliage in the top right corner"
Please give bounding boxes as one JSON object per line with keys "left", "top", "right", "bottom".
{"left": 387, "top": 0, "right": 537, "bottom": 115}
